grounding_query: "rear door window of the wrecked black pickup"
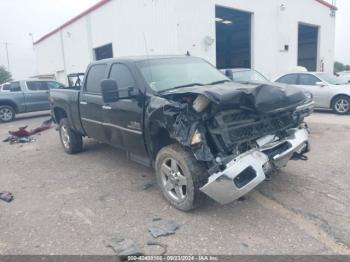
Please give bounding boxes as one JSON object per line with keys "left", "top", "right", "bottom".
{"left": 85, "top": 64, "right": 107, "bottom": 94}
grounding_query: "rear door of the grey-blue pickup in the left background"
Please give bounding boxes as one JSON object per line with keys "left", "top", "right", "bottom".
{"left": 24, "top": 81, "right": 50, "bottom": 112}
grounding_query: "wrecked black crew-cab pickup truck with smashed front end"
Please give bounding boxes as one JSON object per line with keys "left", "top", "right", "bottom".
{"left": 50, "top": 56, "right": 313, "bottom": 211}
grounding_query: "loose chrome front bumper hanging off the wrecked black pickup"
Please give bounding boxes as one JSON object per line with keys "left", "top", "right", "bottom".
{"left": 200, "top": 128, "right": 309, "bottom": 204}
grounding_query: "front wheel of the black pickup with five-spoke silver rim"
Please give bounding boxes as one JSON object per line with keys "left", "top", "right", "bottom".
{"left": 155, "top": 144, "right": 208, "bottom": 211}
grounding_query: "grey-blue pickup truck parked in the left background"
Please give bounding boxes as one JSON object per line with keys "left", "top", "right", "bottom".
{"left": 0, "top": 80, "right": 64, "bottom": 122}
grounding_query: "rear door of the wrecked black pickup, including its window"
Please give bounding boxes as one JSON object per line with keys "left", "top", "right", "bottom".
{"left": 79, "top": 64, "right": 107, "bottom": 142}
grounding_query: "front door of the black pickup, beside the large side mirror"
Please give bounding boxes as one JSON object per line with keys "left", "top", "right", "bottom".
{"left": 103, "top": 63, "right": 146, "bottom": 156}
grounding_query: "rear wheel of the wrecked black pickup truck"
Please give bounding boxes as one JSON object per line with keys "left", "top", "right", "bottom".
{"left": 59, "top": 118, "right": 83, "bottom": 154}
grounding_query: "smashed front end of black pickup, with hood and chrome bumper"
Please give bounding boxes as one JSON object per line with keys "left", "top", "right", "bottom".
{"left": 148, "top": 83, "right": 314, "bottom": 204}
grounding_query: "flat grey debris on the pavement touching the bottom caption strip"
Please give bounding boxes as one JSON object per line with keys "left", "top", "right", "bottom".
{"left": 104, "top": 236, "right": 143, "bottom": 259}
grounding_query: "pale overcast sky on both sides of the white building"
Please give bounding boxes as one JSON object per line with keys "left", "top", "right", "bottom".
{"left": 0, "top": 0, "right": 350, "bottom": 79}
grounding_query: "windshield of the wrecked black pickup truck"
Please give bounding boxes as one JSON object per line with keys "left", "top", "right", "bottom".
{"left": 137, "top": 57, "right": 229, "bottom": 92}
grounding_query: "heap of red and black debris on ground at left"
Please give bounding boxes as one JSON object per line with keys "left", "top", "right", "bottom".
{"left": 3, "top": 119, "right": 52, "bottom": 144}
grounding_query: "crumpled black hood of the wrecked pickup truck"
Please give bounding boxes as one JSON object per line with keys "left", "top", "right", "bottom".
{"left": 162, "top": 82, "right": 307, "bottom": 113}
